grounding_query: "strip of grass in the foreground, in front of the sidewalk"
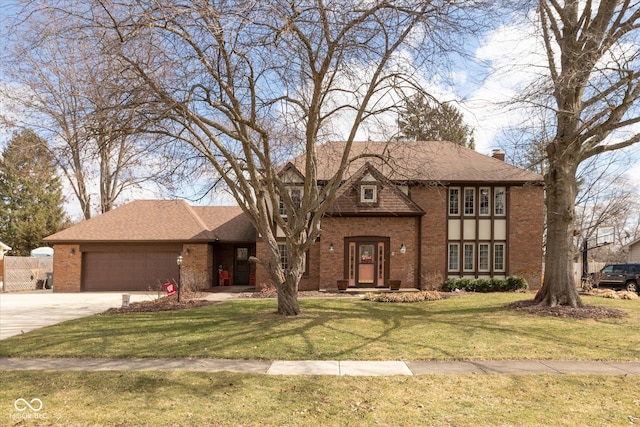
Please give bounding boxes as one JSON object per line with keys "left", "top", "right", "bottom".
{"left": 0, "top": 372, "right": 640, "bottom": 427}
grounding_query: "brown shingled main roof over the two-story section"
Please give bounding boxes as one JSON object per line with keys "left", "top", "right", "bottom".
{"left": 291, "top": 141, "right": 543, "bottom": 183}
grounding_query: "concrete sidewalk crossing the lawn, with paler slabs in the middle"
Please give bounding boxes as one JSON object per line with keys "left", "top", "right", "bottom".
{"left": 0, "top": 358, "right": 640, "bottom": 376}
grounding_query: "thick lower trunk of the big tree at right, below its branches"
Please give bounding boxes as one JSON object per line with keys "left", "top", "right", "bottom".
{"left": 535, "top": 160, "right": 584, "bottom": 308}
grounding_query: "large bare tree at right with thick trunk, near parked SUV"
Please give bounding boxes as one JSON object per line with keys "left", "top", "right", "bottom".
{"left": 536, "top": 0, "right": 640, "bottom": 307}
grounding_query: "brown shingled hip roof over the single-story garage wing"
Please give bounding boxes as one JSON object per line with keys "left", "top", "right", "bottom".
{"left": 44, "top": 200, "right": 255, "bottom": 243}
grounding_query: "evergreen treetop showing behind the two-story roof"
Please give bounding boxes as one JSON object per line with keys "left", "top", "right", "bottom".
{"left": 398, "top": 93, "right": 475, "bottom": 149}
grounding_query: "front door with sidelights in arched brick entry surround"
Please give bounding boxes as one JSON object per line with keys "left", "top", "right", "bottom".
{"left": 346, "top": 237, "right": 389, "bottom": 288}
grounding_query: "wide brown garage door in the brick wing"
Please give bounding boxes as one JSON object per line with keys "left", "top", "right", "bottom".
{"left": 82, "top": 252, "right": 178, "bottom": 291}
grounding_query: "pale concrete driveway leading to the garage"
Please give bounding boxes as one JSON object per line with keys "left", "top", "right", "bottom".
{"left": 0, "top": 291, "right": 158, "bottom": 340}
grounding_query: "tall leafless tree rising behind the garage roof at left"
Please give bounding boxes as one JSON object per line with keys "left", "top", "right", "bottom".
{"left": 2, "top": 8, "right": 169, "bottom": 219}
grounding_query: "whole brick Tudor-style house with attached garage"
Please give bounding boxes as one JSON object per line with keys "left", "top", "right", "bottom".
{"left": 46, "top": 141, "right": 544, "bottom": 292}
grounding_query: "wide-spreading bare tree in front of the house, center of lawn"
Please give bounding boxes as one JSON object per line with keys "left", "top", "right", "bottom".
{"left": 69, "top": 0, "right": 472, "bottom": 315}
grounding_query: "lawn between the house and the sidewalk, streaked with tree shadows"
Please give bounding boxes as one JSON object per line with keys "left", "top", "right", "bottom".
{"left": 0, "top": 294, "right": 640, "bottom": 360}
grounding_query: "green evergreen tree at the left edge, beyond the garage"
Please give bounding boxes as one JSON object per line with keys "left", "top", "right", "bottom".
{"left": 0, "top": 130, "right": 66, "bottom": 255}
